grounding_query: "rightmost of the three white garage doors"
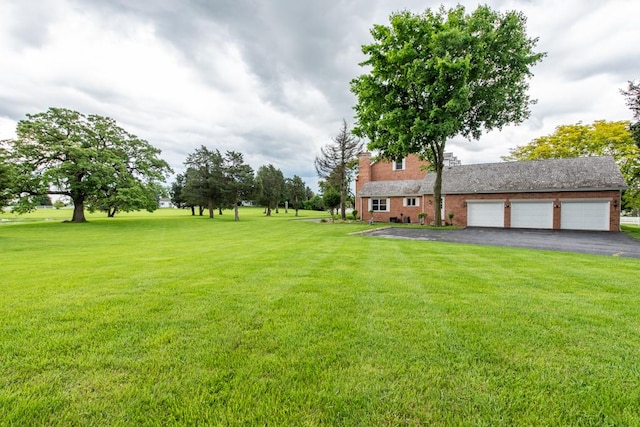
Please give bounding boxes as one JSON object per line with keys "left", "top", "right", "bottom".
{"left": 560, "top": 201, "right": 609, "bottom": 231}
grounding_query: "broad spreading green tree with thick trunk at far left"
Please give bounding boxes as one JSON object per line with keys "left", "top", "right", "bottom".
{"left": 10, "top": 108, "right": 171, "bottom": 222}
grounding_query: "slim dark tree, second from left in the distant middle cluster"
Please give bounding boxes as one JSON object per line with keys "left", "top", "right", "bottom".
{"left": 224, "top": 151, "right": 256, "bottom": 221}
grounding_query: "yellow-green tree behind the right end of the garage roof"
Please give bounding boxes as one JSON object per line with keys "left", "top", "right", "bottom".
{"left": 502, "top": 120, "right": 640, "bottom": 210}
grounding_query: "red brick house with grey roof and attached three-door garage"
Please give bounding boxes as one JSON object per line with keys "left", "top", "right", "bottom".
{"left": 356, "top": 153, "right": 626, "bottom": 231}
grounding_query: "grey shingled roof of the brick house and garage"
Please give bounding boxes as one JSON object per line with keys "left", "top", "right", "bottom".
{"left": 360, "top": 156, "right": 627, "bottom": 197}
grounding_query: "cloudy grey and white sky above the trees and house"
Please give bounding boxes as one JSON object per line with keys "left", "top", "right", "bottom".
{"left": 0, "top": 0, "right": 640, "bottom": 190}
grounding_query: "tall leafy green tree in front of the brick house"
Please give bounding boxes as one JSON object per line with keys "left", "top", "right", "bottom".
{"left": 351, "top": 6, "right": 544, "bottom": 223}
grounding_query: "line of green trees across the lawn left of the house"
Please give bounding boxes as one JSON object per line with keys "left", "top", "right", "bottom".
{"left": 0, "top": 107, "right": 344, "bottom": 222}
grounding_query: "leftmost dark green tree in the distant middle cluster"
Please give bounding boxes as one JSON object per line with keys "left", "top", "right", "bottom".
{"left": 183, "top": 145, "right": 224, "bottom": 218}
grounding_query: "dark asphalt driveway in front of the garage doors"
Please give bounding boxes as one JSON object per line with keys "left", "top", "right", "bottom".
{"left": 366, "top": 227, "right": 640, "bottom": 258}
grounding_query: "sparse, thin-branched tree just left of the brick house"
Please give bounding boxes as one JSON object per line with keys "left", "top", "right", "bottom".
{"left": 315, "top": 119, "right": 363, "bottom": 220}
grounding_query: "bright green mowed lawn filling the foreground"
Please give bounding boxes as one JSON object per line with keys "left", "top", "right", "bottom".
{"left": 0, "top": 209, "right": 640, "bottom": 426}
